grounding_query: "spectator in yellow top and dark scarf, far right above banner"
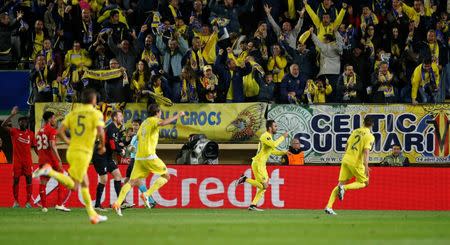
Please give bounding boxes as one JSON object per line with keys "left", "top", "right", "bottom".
{"left": 411, "top": 58, "right": 440, "bottom": 105}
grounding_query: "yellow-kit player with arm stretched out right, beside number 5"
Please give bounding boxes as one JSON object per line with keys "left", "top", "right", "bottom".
{"left": 112, "top": 104, "right": 184, "bottom": 216}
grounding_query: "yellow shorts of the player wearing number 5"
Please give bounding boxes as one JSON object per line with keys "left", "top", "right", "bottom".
{"left": 66, "top": 151, "right": 92, "bottom": 183}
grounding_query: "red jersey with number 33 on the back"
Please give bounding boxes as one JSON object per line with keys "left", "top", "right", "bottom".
{"left": 36, "top": 123, "right": 58, "bottom": 164}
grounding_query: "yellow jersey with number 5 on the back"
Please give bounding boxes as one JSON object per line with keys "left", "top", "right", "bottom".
{"left": 62, "top": 104, "right": 105, "bottom": 155}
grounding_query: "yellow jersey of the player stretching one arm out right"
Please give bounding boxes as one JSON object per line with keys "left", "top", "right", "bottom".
{"left": 136, "top": 117, "right": 161, "bottom": 160}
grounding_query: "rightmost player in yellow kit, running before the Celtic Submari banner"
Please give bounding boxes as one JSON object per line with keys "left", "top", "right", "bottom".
{"left": 325, "top": 116, "right": 375, "bottom": 215}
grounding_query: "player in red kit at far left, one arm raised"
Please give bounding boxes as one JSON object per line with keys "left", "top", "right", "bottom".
{"left": 1, "top": 106, "right": 36, "bottom": 208}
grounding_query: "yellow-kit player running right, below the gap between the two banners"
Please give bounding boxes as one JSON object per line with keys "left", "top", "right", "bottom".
{"left": 236, "top": 120, "right": 291, "bottom": 211}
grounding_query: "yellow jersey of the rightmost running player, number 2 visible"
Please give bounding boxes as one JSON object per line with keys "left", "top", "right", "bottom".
{"left": 342, "top": 127, "right": 375, "bottom": 166}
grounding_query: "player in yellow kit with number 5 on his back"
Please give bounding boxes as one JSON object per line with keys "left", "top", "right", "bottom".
{"left": 33, "top": 89, "right": 108, "bottom": 224}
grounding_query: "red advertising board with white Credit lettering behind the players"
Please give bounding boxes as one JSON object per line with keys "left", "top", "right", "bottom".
{"left": 0, "top": 164, "right": 450, "bottom": 210}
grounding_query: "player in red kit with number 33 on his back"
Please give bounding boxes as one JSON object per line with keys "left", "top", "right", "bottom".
{"left": 36, "top": 111, "right": 70, "bottom": 213}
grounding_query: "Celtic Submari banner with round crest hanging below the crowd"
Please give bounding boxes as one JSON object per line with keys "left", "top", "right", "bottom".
{"left": 268, "top": 104, "right": 450, "bottom": 164}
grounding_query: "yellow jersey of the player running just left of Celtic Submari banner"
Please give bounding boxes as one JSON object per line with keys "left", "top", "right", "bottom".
{"left": 252, "top": 132, "right": 286, "bottom": 165}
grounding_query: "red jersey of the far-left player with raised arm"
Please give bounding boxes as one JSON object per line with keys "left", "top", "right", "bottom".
{"left": 9, "top": 128, "right": 36, "bottom": 165}
